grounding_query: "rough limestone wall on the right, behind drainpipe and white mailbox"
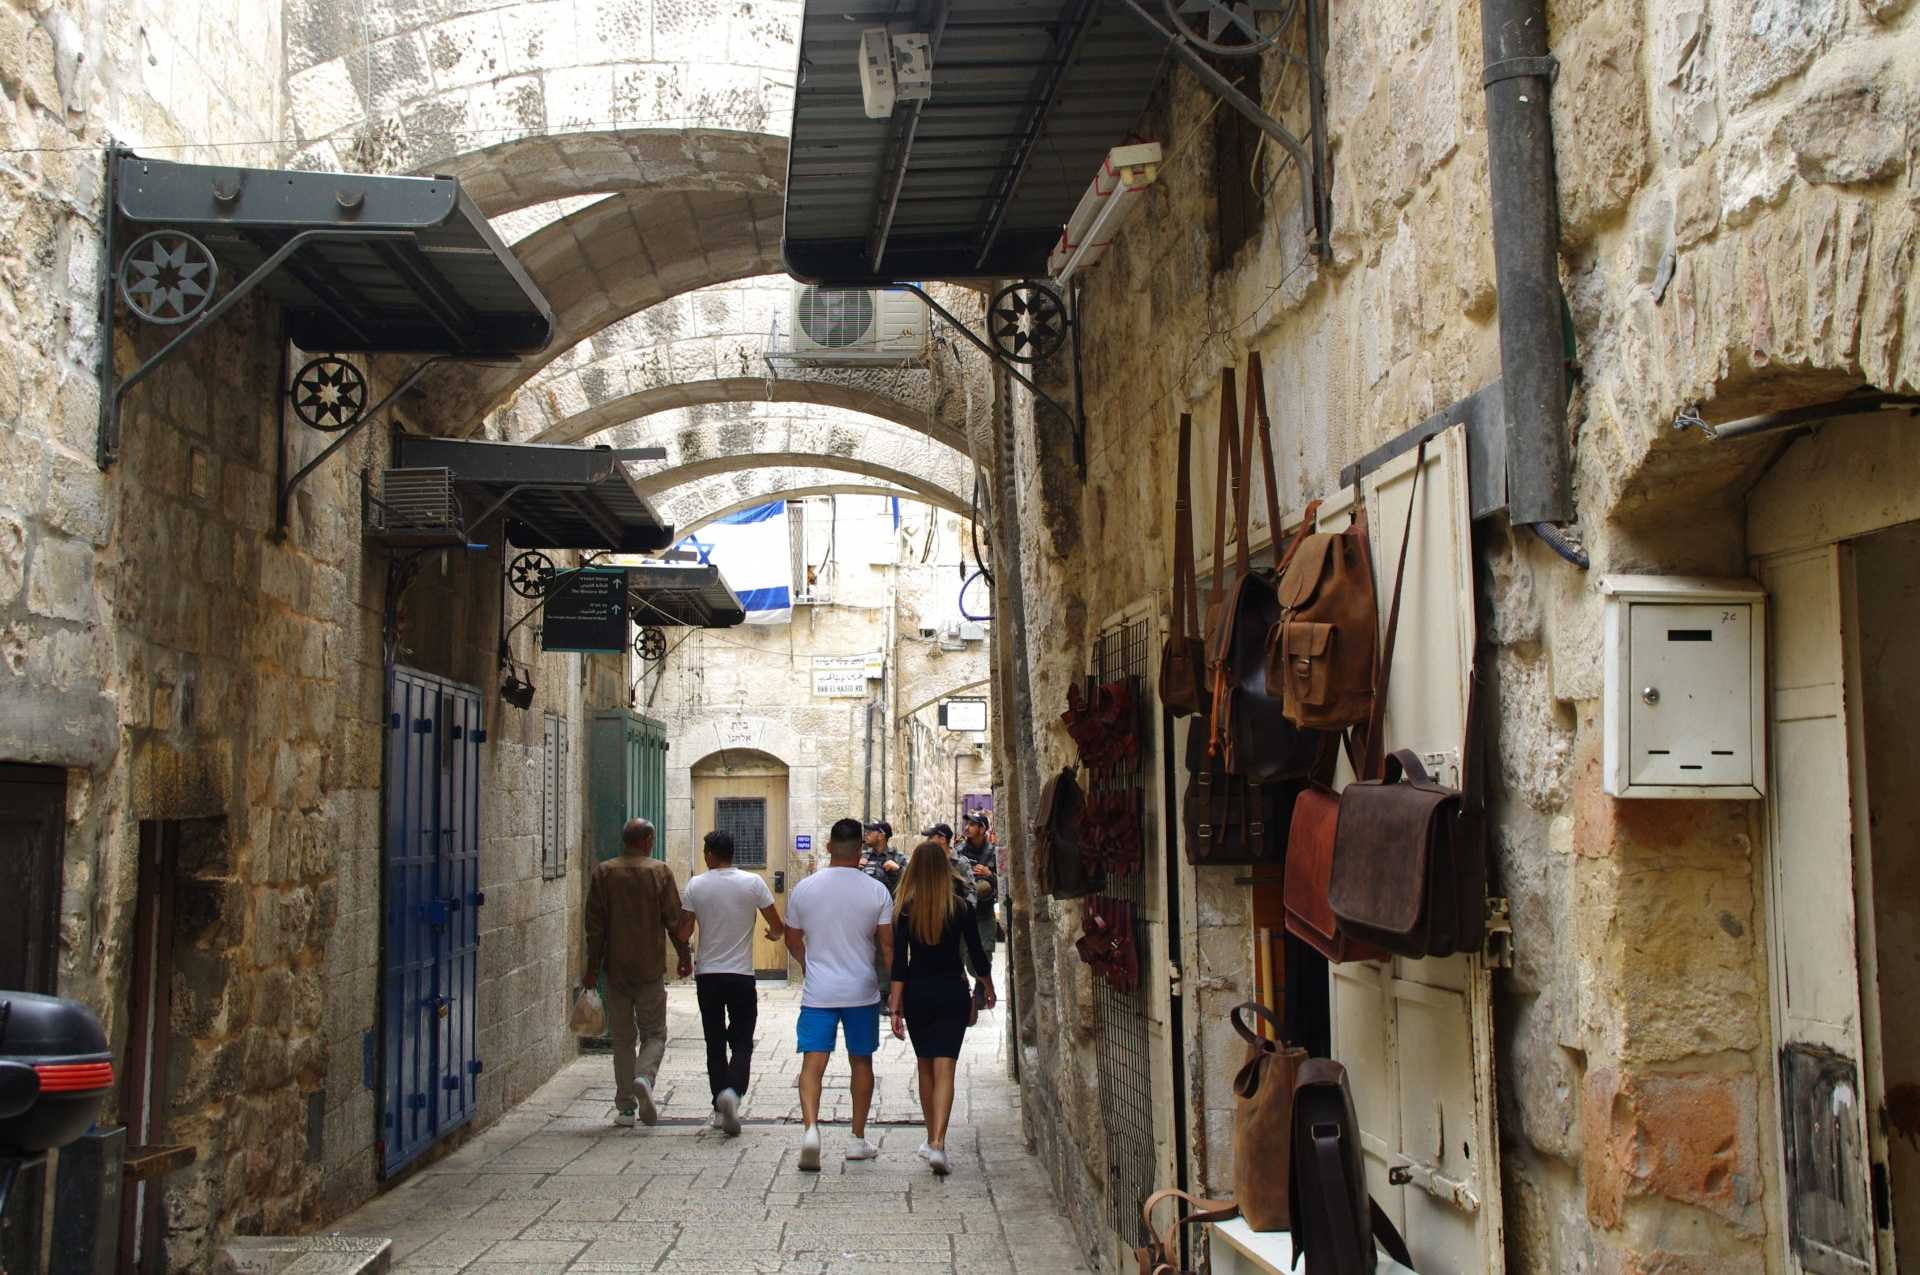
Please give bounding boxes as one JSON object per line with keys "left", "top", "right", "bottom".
{"left": 1020, "top": 0, "right": 1920, "bottom": 1271}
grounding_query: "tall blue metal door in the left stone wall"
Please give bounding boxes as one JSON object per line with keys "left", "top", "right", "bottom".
{"left": 380, "top": 668, "right": 486, "bottom": 1173}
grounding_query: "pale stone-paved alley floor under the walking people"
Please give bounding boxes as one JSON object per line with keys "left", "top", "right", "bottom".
{"left": 334, "top": 967, "right": 1089, "bottom": 1275}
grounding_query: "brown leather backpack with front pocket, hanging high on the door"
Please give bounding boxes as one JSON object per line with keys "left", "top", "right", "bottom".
{"left": 1263, "top": 507, "right": 1380, "bottom": 730}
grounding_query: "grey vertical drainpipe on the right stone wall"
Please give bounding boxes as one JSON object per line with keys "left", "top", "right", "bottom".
{"left": 1480, "top": 0, "right": 1572, "bottom": 524}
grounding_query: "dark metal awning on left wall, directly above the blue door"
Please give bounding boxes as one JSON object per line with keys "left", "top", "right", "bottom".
{"left": 394, "top": 434, "right": 674, "bottom": 553}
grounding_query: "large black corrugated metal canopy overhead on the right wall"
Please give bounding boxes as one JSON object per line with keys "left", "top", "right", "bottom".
{"left": 783, "top": 0, "right": 1167, "bottom": 286}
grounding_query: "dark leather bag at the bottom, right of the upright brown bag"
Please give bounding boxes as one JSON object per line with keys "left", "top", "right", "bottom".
{"left": 1292, "top": 1058, "right": 1413, "bottom": 1275}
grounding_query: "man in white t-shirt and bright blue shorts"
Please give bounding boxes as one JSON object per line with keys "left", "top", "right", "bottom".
{"left": 787, "top": 820, "right": 893, "bottom": 1173}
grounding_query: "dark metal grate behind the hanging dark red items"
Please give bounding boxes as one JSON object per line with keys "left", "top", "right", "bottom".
{"left": 1092, "top": 618, "right": 1160, "bottom": 1242}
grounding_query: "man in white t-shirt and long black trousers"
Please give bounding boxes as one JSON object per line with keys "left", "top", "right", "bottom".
{"left": 674, "top": 831, "right": 785, "bottom": 1137}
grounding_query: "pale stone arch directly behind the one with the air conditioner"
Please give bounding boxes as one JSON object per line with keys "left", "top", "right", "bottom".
{"left": 614, "top": 403, "right": 973, "bottom": 505}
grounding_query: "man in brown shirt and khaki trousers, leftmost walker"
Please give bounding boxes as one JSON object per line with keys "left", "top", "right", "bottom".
{"left": 580, "top": 820, "right": 693, "bottom": 1127}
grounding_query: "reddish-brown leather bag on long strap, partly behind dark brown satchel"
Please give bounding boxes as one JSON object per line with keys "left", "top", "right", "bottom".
{"left": 1284, "top": 442, "right": 1427, "bottom": 964}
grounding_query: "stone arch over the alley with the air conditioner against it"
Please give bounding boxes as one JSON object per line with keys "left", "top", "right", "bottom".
{"left": 488, "top": 275, "right": 975, "bottom": 449}
